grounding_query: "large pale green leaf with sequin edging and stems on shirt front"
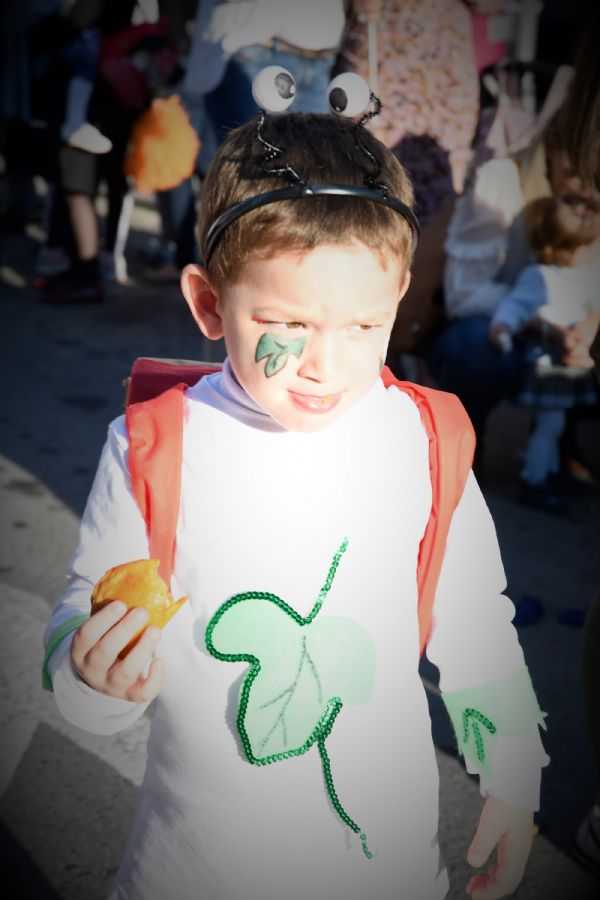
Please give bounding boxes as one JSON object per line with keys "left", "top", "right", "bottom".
{"left": 205, "top": 538, "right": 375, "bottom": 859}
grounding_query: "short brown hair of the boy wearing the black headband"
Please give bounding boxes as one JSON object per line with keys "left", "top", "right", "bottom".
{"left": 197, "top": 113, "right": 413, "bottom": 287}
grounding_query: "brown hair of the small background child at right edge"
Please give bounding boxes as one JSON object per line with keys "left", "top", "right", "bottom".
{"left": 524, "top": 197, "right": 593, "bottom": 266}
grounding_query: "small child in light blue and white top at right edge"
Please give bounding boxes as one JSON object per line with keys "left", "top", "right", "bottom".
{"left": 489, "top": 197, "right": 600, "bottom": 513}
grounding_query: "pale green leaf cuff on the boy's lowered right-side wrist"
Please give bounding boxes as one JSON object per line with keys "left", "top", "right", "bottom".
{"left": 442, "top": 667, "right": 546, "bottom": 778}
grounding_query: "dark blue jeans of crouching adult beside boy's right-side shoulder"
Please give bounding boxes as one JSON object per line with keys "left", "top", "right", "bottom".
{"left": 427, "top": 315, "right": 524, "bottom": 438}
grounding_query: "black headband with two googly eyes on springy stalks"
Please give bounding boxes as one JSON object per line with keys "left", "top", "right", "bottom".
{"left": 203, "top": 66, "right": 419, "bottom": 266}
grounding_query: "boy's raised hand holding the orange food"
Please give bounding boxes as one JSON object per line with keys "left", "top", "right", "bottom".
{"left": 71, "top": 601, "right": 163, "bottom": 703}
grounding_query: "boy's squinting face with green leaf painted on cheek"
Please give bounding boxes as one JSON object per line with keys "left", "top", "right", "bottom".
{"left": 184, "top": 241, "right": 409, "bottom": 432}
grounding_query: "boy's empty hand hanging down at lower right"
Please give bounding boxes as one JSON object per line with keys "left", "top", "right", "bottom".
{"left": 467, "top": 797, "right": 533, "bottom": 900}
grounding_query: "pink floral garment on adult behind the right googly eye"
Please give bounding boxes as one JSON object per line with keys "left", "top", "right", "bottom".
{"left": 340, "top": 0, "right": 479, "bottom": 220}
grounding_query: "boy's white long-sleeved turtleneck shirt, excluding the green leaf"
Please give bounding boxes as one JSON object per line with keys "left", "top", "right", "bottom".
{"left": 47, "top": 363, "right": 547, "bottom": 900}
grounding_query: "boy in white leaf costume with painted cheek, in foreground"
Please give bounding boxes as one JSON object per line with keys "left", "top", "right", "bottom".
{"left": 47, "top": 107, "right": 546, "bottom": 900}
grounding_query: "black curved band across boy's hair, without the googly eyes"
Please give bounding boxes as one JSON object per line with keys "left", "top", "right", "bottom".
{"left": 203, "top": 182, "right": 420, "bottom": 266}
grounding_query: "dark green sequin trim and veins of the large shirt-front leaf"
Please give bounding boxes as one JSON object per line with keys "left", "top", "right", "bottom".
{"left": 205, "top": 538, "right": 373, "bottom": 859}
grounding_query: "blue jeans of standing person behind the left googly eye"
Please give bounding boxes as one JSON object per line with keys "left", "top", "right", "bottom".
{"left": 206, "top": 41, "right": 336, "bottom": 143}
